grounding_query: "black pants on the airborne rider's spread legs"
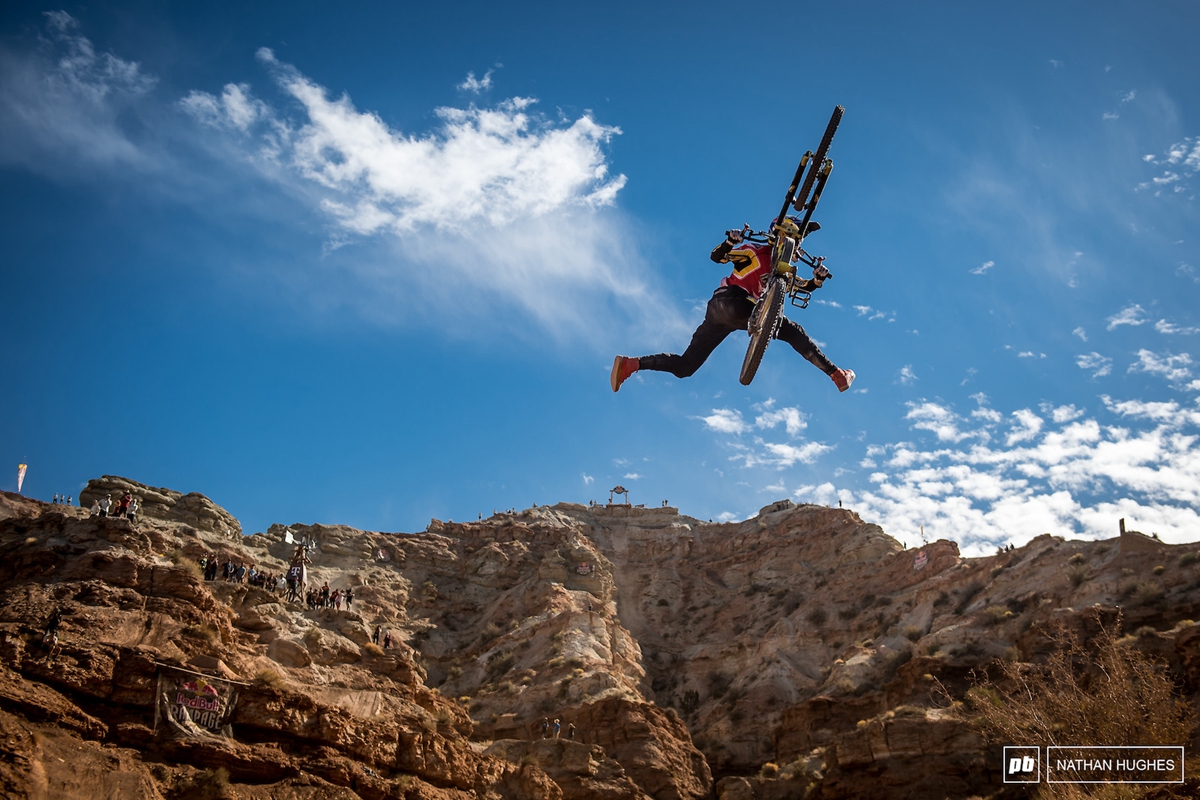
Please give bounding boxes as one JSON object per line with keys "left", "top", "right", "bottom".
{"left": 637, "top": 287, "right": 838, "bottom": 378}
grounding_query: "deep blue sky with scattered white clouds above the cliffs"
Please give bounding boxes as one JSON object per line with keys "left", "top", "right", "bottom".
{"left": 0, "top": 2, "right": 1200, "bottom": 552}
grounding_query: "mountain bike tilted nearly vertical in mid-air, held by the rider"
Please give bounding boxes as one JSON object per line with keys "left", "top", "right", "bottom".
{"left": 739, "top": 106, "right": 846, "bottom": 386}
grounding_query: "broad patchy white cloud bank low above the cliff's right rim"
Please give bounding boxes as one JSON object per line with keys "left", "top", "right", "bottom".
{"left": 840, "top": 397, "right": 1200, "bottom": 555}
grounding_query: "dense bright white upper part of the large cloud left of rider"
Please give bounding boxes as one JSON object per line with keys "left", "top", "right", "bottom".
{"left": 206, "top": 48, "right": 625, "bottom": 234}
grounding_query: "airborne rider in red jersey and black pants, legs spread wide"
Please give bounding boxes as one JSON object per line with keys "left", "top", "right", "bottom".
{"left": 610, "top": 217, "right": 854, "bottom": 392}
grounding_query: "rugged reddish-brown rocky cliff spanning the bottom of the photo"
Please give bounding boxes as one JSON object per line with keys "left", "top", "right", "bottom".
{"left": 0, "top": 476, "right": 1200, "bottom": 800}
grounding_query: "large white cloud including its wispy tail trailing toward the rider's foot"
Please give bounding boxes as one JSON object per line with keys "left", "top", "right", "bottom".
{"left": 181, "top": 48, "right": 686, "bottom": 340}
